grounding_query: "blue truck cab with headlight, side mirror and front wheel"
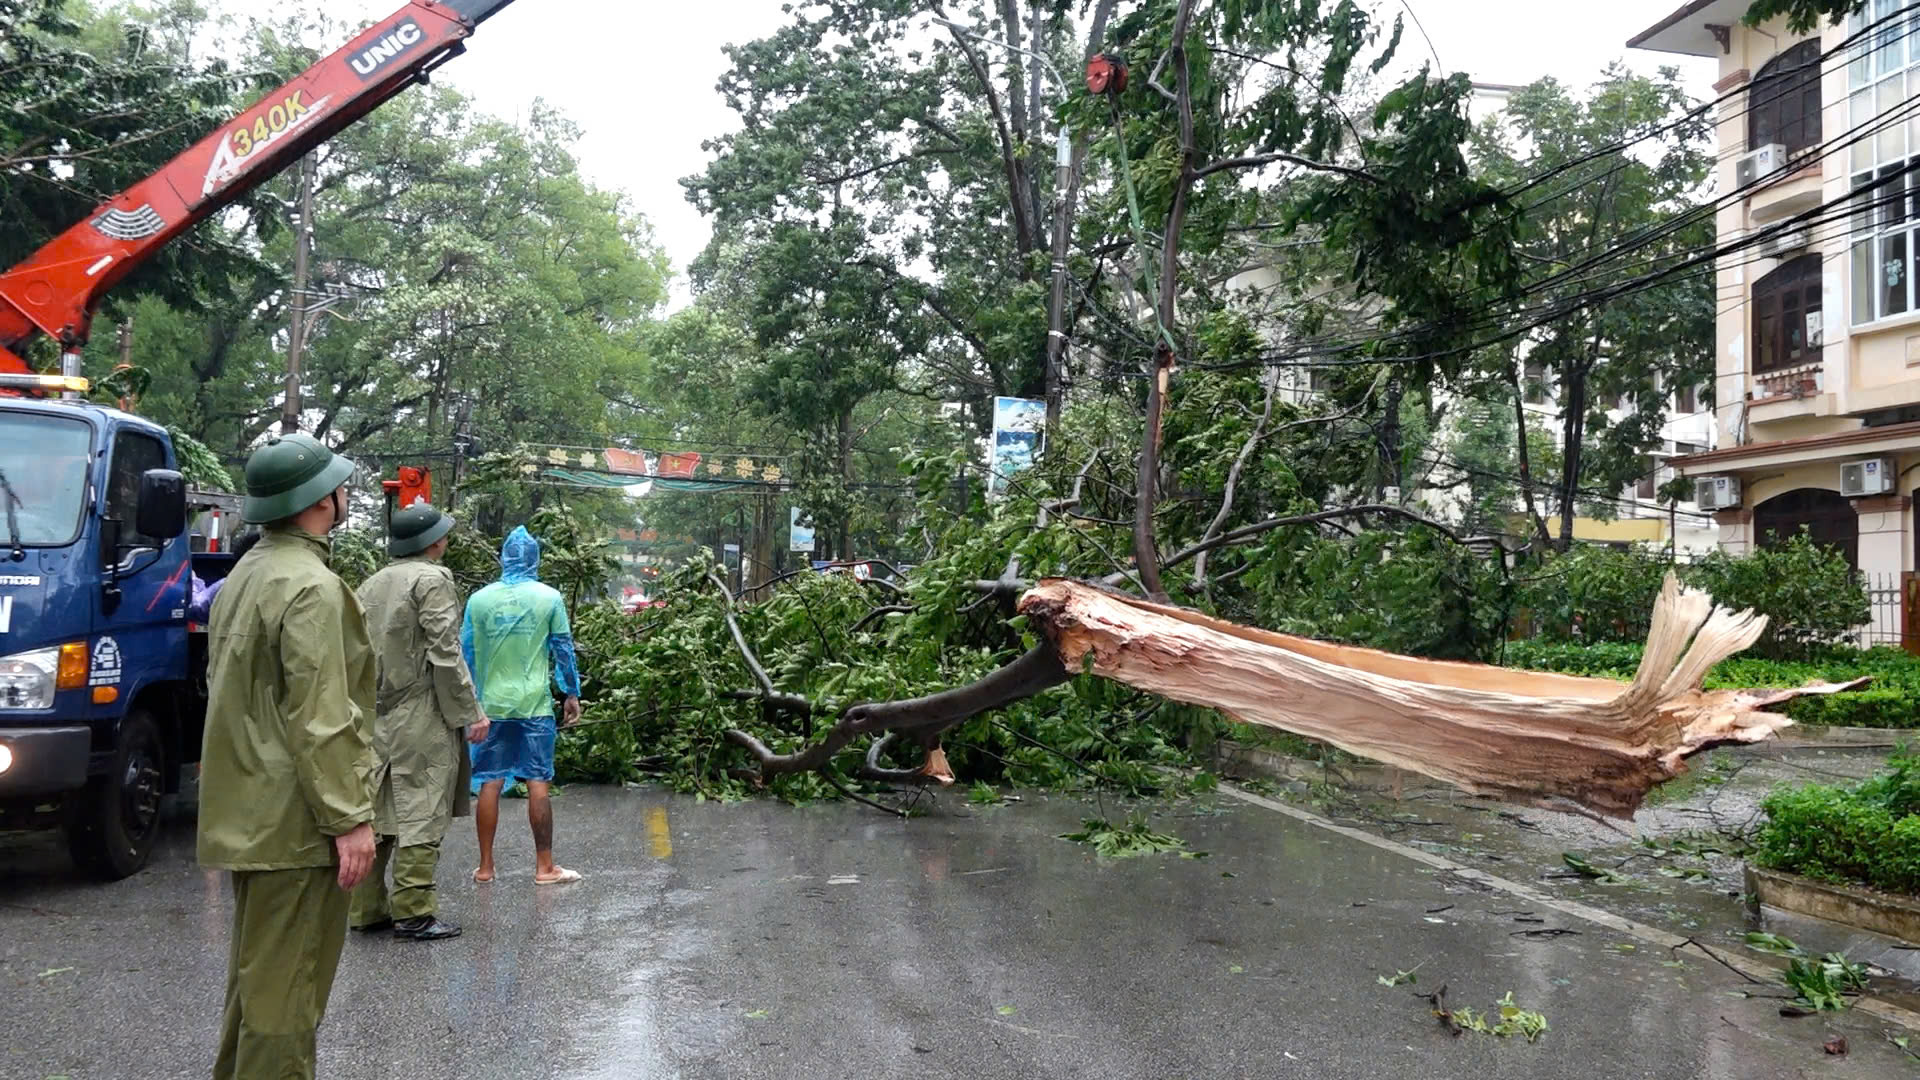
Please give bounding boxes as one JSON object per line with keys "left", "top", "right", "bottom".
{"left": 0, "top": 386, "right": 200, "bottom": 878}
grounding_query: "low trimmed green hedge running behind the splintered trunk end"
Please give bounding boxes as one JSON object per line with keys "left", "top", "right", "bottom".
{"left": 1503, "top": 640, "right": 1920, "bottom": 728}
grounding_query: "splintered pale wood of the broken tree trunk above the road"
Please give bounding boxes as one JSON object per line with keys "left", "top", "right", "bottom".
{"left": 1020, "top": 575, "right": 1866, "bottom": 819}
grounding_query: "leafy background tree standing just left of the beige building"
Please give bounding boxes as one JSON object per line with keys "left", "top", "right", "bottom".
{"left": 1475, "top": 65, "right": 1715, "bottom": 552}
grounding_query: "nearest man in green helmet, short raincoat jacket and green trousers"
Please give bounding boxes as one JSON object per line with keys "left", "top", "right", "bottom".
{"left": 200, "top": 434, "right": 374, "bottom": 1080}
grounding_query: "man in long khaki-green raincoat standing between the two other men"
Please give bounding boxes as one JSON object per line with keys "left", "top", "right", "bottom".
{"left": 351, "top": 505, "right": 488, "bottom": 942}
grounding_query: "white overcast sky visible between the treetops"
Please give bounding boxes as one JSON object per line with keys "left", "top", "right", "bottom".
{"left": 215, "top": 0, "right": 1716, "bottom": 298}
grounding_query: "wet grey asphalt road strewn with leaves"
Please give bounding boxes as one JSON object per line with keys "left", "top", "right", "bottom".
{"left": 0, "top": 788, "right": 1920, "bottom": 1080}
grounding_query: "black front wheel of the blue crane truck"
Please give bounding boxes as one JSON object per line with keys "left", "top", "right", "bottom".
{"left": 67, "top": 709, "right": 165, "bottom": 882}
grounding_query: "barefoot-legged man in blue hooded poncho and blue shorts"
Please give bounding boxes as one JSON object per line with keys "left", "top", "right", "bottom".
{"left": 461, "top": 527, "right": 580, "bottom": 886}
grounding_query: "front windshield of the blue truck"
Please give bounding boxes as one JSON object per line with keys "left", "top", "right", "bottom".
{"left": 0, "top": 409, "right": 92, "bottom": 548}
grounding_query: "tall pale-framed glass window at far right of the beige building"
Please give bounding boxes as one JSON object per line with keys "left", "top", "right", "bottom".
{"left": 1847, "top": 0, "right": 1920, "bottom": 325}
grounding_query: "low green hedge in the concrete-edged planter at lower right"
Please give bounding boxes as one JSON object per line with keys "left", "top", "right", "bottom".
{"left": 1753, "top": 755, "right": 1920, "bottom": 894}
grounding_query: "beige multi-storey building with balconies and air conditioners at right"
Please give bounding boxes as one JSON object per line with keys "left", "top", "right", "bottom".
{"left": 1628, "top": 0, "right": 1920, "bottom": 644}
